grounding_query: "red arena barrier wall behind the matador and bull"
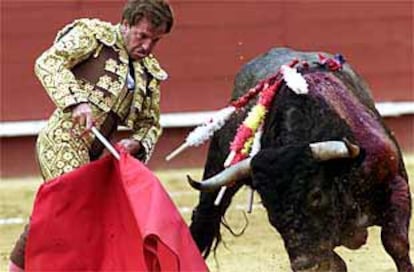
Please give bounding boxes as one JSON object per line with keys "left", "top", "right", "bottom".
{"left": 0, "top": 0, "right": 414, "bottom": 176}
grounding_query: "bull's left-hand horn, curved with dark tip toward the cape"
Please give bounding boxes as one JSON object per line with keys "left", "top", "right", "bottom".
{"left": 187, "top": 158, "right": 251, "bottom": 191}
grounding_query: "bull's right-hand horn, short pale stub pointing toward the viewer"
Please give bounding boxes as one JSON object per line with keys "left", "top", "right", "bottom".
{"left": 309, "top": 139, "right": 360, "bottom": 161}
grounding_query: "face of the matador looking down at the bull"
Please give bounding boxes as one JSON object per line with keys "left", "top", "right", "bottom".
{"left": 121, "top": 18, "right": 165, "bottom": 60}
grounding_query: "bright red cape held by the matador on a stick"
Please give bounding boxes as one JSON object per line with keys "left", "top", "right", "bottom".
{"left": 25, "top": 153, "right": 208, "bottom": 271}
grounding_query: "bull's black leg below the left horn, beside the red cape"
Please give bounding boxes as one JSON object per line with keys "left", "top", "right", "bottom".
{"left": 190, "top": 183, "right": 243, "bottom": 258}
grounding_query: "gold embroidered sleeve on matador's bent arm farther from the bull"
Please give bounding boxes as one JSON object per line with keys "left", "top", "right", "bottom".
{"left": 35, "top": 21, "right": 98, "bottom": 110}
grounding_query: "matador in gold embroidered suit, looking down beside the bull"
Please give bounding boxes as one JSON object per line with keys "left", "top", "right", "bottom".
{"left": 9, "top": 0, "right": 173, "bottom": 271}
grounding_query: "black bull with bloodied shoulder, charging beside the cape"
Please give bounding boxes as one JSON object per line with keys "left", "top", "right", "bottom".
{"left": 190, "top": 48, "right": 412, "bottom": 271}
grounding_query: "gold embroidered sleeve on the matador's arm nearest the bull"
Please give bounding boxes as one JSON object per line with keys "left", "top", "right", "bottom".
{"left": 132, "top": 79, "right": 162, "bottom": 162}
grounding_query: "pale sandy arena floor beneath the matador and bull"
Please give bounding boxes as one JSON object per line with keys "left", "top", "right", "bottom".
{"left": 0, "top": 156, "right": 414, "bottom": 272}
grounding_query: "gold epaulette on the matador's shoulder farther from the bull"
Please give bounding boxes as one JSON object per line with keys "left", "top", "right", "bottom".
{"left": 55, "top": 18, "right": 116, "bottom": 46}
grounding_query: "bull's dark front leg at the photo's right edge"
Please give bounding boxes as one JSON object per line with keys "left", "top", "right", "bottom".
{"left": 381, "top": 176, "right": 413, "bottom": 272}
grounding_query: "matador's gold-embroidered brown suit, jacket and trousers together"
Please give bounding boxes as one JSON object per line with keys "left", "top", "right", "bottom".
{"left": 35, "top": 19, "right": 167, "bottom": 180}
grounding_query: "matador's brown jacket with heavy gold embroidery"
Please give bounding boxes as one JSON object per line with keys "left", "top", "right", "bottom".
{"left": 35, "top": 19, "right": 167, "bottom": 161}
